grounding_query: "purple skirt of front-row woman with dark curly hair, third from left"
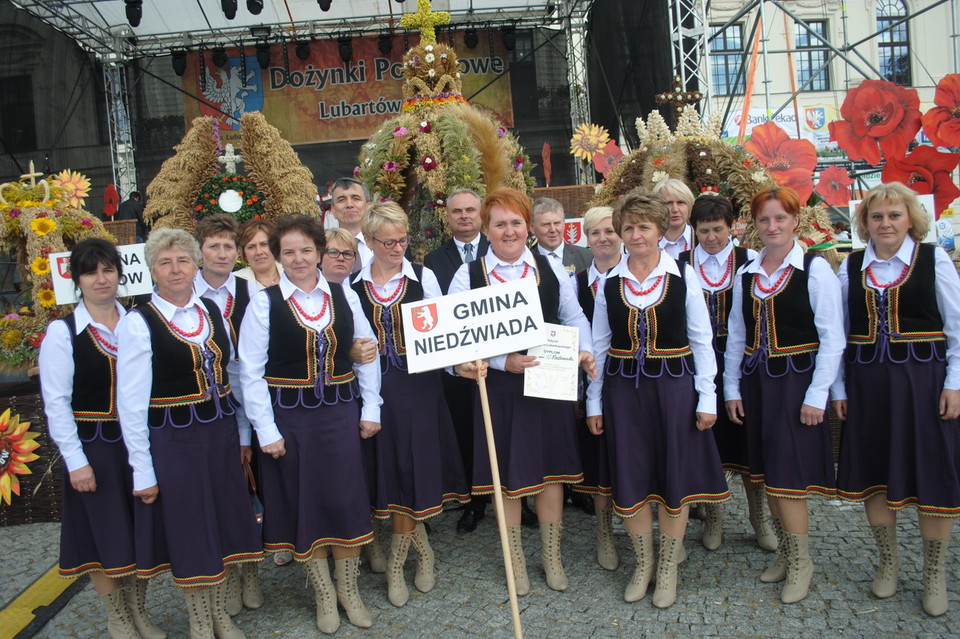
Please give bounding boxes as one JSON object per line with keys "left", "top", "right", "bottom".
{"left": 260, "top": 399, "right": 380, "bottom": 561}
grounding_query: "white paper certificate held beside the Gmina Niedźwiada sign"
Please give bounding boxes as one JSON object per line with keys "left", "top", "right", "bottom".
{"left": 523, "top": 324, "right": 580, "bottom": 402}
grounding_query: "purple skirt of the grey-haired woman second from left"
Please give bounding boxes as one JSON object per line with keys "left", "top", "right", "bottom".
{"left": 136, "top": 415, "right": 263, "bottom": 587}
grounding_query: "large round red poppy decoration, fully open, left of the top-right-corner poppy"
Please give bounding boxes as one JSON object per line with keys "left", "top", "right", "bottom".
{"left": 830, "top": 80, "right": 920, "bottom": 164}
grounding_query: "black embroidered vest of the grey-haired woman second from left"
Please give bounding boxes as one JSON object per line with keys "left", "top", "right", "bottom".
{"left": 134, "top": 298, "right": 231, "bottom": 426}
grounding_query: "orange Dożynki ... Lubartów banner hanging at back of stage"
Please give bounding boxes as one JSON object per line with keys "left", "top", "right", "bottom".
{"left": 183, "top": 32, "right": 513, "bottom": 148}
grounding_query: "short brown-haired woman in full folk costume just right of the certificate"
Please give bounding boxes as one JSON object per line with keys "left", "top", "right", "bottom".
{"left": 587, "top": 189, "right": 730, "bottom": 608}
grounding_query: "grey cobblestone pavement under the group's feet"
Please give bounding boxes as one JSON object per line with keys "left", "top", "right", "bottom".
{"left": 0, "top": 487, "right": 960, "bottom": 639}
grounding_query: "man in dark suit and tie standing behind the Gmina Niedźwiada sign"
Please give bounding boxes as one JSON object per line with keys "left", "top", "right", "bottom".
{"left": 423, "top": 189, "right": 490, "bottom": 532}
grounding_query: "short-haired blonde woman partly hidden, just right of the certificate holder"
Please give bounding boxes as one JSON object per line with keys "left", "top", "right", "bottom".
{"left": 573, "top": 206, "right": 623, "bottom": 570}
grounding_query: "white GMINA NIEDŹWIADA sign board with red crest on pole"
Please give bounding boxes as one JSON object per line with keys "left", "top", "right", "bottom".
{"left": 401, "top": 278, "right": 546, "bottom": 373}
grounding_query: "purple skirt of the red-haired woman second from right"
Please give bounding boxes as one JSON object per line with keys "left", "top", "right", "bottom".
{"left": 740, "top": 366, "right": 836, "bottom": 498}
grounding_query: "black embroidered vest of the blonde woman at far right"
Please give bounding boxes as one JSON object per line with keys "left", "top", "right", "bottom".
{"left": 846, "top": 242, "right": 946, "bottom": 361}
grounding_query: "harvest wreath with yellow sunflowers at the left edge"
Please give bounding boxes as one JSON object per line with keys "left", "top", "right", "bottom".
{"left": 0, "top": 164, "right": 116, "bottom": 370}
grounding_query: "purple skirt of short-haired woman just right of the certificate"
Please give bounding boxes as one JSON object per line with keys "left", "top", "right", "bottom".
{"left": 603, "top": 374, "right": 730, "bottom": 517}
